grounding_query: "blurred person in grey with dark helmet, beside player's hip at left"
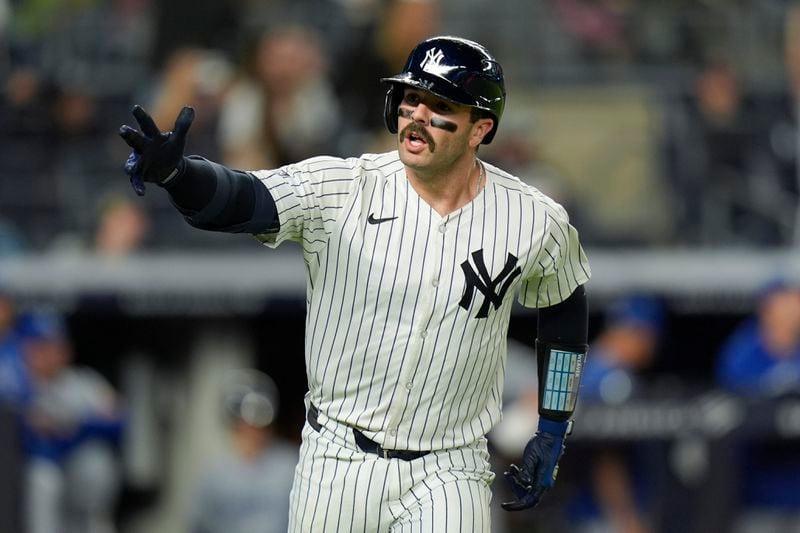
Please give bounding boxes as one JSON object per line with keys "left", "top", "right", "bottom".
{"left": 190, "top": 369, "right": 298, "bottom": 533}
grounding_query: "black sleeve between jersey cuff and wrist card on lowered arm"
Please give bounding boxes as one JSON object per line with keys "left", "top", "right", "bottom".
{"left": 538, "top": 285, "right": 589, "bottom": 344}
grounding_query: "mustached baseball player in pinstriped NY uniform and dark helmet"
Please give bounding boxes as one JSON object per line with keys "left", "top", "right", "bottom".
{"left": 120, "top": 37, "right": 590, "bottom": 532}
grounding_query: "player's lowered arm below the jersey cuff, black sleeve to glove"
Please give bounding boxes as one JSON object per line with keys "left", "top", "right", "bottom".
{"left": 502, "top": 285, "right": 588, "bottom": 511}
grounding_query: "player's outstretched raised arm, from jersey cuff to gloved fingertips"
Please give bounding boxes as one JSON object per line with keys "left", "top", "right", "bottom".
{"left": 120, "top": 106, "right": 278, "bottom": 234}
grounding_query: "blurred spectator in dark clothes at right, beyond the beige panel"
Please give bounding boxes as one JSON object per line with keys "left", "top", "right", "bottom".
{"left": 665, "top": 58, "right": 795, "bottom": 246}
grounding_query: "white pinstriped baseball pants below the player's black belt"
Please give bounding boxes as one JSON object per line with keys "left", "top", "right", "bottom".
{"left": 289, "top": 406, "right": 494, "bottom": 533}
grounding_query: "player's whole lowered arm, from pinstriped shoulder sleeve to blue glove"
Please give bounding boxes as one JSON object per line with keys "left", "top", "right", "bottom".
{"left": 502, "top": 196, "right": 590, "bottom": 511}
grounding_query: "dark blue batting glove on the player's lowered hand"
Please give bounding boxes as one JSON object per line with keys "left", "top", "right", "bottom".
{"left": 501, "top": 418, "right": 571, "bottom": 511}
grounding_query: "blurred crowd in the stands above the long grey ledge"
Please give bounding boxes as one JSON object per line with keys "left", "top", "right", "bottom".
{"left": 0, "top": 0, "right": 800, "bottom": 253}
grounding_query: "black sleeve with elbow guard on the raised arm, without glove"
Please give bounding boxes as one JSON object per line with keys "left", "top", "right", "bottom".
{"left": 164, "top": 156, "right": 279, "bottom": 234}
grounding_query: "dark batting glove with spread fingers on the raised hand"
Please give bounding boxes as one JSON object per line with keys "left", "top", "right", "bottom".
{"left": 119, "top": 105, "right": 194, "bottom": 196}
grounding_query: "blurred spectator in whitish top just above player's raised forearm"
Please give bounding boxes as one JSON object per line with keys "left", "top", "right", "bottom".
{"left": 220, "top": 26, "right": 341, "bottom": 169}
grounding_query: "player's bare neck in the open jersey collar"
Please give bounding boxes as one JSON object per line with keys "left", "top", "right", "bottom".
{"left": 406, "top": 156, "right": 486, "bottom": 216}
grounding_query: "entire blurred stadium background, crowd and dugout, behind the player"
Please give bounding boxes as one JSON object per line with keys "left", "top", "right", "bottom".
{"left": 0, "top": 0, "right": 800, "bottom": 533}
